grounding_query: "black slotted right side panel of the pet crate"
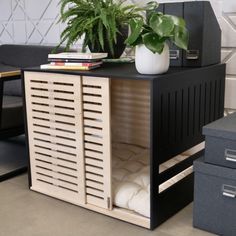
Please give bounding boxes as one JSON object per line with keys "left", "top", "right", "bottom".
{"left": 150, "top": 64, "right": 225, "bottom": 229}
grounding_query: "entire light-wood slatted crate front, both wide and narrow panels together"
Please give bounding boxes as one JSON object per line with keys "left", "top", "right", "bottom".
{"left": 24, "top": 72, "right": 112, "bottom": 209}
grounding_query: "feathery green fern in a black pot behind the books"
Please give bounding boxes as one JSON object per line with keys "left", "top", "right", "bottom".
{"left": 59, "top": 0, "right": 143, "bottom": 58}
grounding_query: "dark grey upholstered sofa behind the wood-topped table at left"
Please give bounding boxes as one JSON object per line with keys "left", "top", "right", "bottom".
{"left": 0, "top": 44, "right": 64, "bottom": 139}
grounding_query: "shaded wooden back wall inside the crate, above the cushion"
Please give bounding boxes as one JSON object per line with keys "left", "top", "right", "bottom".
{"left": 111, "top": 79, "right": 150, "bottom": 147}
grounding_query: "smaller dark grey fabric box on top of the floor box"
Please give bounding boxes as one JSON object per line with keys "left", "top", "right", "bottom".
{"left": 203, "top": 113, "right": 236, "bottom": 168}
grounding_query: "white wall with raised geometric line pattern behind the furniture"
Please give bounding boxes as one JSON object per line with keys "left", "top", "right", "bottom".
{"left": 0, "top": 0, "right": 236, "bottom": 108}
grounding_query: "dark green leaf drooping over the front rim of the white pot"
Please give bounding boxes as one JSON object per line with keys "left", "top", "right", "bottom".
{"left": 143, "top": 33, "right": 165, "bottom": 54}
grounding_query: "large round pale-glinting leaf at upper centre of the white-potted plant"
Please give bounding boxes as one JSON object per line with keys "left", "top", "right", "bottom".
{"left": 149, "top": 14, "right": 174, "bottom": 37}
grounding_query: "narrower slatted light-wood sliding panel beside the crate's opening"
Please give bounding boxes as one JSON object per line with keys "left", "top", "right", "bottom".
{"left": 82, "top": 77, "right": 112, "bottom": 209}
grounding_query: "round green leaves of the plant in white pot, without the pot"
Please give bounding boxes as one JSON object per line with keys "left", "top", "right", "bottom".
{"left": 126, "top": 2, "right": 189, "bottom": 54}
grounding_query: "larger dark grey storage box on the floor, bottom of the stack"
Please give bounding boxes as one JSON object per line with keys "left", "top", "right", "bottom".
{"left": 193, "top": 158, "right": 236, "bottom": 236}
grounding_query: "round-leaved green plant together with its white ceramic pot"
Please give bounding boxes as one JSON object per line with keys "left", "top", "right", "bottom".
{"left": 126, "top": 2, "right": 189, "bottom": 74}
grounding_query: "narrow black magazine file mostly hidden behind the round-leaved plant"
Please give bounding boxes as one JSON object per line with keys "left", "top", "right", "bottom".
{"left": 164, "top": 2, "right": 184, "bottom": 66}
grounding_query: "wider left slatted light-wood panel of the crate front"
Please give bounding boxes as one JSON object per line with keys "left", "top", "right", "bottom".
{"left": 25, "top": 72, "right": 85, "bottom": 204}
